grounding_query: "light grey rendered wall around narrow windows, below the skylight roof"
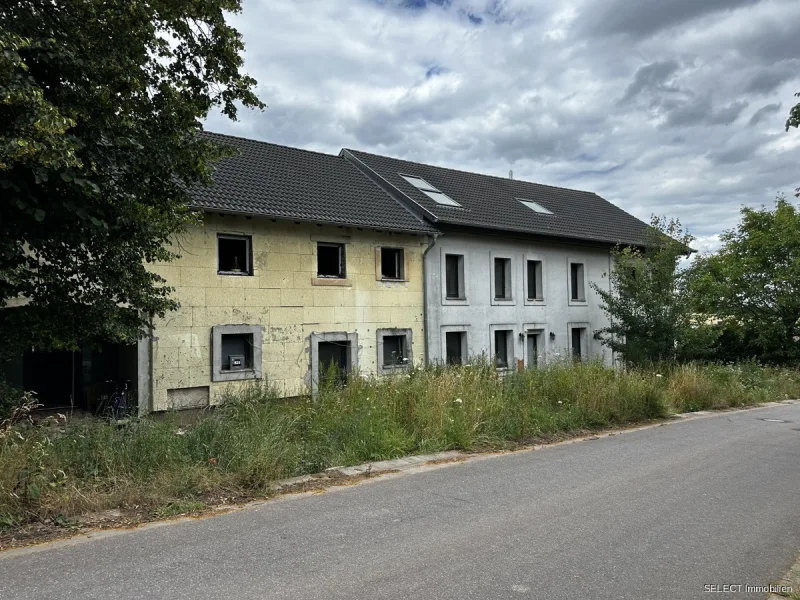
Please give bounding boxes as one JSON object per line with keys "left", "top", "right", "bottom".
{"left": 425, "top": 233, "right": 613, "bottom": 364}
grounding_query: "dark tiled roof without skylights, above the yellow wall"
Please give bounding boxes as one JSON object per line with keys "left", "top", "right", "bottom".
{"left": 192, "top": 132, "right": 435, "bottom": 233}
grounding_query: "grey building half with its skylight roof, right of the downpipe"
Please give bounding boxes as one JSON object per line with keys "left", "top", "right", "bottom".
{"left": 342, "top": 150, "right": 648, "bottom": 369}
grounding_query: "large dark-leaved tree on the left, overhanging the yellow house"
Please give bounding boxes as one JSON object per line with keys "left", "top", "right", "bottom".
{"left": 0, "top": 0, "right": 262, "bottom": 355}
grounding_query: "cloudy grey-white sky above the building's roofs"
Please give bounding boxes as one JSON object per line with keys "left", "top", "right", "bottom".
{"left": 206, "top": 0, "right": 800, "bottom": 249}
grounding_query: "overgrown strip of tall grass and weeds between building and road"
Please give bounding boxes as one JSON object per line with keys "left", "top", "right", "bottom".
{"left": 0, "top": 364, "right": 800, "bottom": 528}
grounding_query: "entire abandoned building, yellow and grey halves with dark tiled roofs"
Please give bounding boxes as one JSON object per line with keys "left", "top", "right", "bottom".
{"left": 4, "top": 133, "right": 648, "bottom": 414}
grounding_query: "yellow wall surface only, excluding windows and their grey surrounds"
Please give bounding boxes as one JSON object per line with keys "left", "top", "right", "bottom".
{"left": 151, "top": 215, "right": 429, "bottom": 410}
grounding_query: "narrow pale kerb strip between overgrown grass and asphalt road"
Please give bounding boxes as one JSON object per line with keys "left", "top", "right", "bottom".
{"left": 0, "top": 400, "right": 800, "bottom": 560}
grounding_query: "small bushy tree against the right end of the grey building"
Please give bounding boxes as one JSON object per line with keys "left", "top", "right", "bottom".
{"left": 592, "top": 217, "right": 707, "bottom": 365}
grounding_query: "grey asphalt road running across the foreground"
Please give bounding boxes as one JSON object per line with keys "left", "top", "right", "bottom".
{"left": 0, "top": 404, "right": 800, "bottom": 600}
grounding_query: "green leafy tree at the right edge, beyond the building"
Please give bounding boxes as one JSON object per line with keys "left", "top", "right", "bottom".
{"left": 689, "top": 198, "right": 800, "bottom": 363}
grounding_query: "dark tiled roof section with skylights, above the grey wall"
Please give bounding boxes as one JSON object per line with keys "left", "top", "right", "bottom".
{"left": 345, "top": 150, "right": 649, "bottom": 245}
